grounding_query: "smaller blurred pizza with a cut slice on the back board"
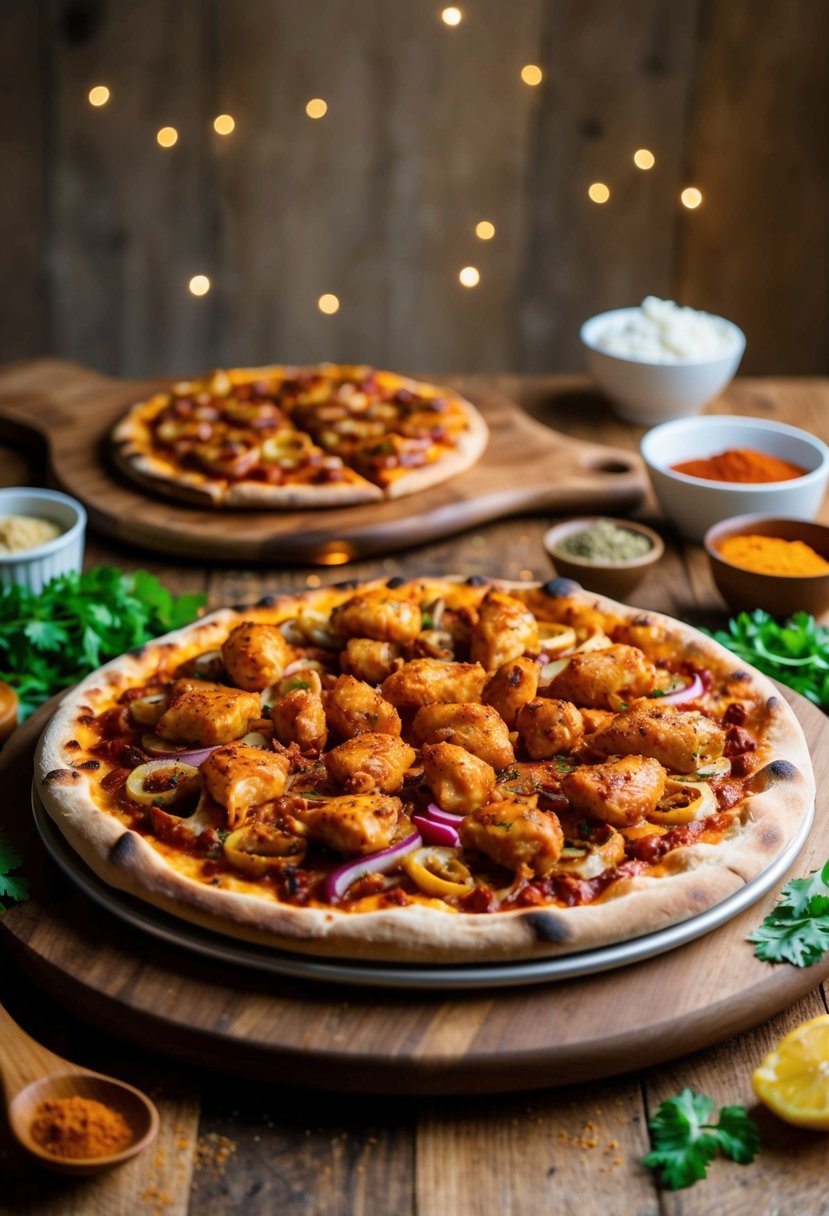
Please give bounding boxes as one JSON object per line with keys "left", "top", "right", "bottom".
{"left": 111, "top": 364, "right": 489, "bottom": 508}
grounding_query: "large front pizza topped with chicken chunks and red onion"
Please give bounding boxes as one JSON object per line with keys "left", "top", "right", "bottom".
{"left": 36, "top": 576, "right": 814, "bottom": 963}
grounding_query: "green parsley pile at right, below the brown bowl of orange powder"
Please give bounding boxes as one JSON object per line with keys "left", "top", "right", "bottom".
{"left": 706, "top": 608, "right": 829, "bottom": 705}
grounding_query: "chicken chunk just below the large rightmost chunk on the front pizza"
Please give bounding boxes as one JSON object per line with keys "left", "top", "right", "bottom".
{"left": 562, "top": 756, "right": 666, "bottom": 828}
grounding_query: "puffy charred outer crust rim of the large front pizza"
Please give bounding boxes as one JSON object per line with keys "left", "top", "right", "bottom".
{"left": 35, "top": 579, "right": 814, "bottom": 964}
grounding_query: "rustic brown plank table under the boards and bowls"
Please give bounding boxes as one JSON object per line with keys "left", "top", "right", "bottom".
{"left": 0, "top": 377, "right": 829, "bottom": 1216}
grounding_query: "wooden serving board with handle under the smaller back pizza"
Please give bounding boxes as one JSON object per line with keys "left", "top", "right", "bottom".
{"left": 0, "top": 359, "right": 647, "bottom": 565}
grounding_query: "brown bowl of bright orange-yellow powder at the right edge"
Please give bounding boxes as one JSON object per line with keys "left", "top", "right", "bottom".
{"left": 705, "top": 514, "right": 829, "bottom": 617}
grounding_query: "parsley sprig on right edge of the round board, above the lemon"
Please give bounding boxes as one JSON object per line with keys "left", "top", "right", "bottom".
{"left": 749, "top": 861, "right": 829, "bottom": 967}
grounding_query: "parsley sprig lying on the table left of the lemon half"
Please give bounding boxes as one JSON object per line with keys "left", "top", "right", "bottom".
{"left": 642, "top": 1087, "right": 760, "bottom": 1190}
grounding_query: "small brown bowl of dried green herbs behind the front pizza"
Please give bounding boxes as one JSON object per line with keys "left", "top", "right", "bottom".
{"left": 543, "top": 516, "right": 665, "bottom": 599}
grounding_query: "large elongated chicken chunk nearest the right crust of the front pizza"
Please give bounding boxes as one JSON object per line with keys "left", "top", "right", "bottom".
{"left": 590, "top": 700, "right": 726, "bottom": 772}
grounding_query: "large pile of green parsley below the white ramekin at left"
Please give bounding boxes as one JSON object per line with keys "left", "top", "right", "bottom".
{"left": 0, "top": 565, "right": 205, "bottom": 721}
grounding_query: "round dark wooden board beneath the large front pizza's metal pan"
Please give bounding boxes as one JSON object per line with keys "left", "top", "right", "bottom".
{"left": 0, "top": 692, "right": 829, "bottom": 1093}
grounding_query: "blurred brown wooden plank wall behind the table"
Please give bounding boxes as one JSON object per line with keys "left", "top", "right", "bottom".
{"left": 0, "top": 0, "right": 829, "bottom": 375}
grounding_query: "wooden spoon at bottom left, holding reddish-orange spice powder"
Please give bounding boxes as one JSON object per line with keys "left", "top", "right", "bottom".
{"left": 0, "top": 1006, "right": 158, "bottom": 1175}
